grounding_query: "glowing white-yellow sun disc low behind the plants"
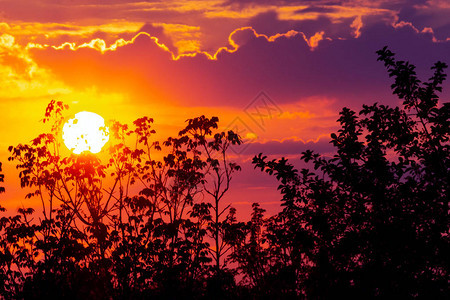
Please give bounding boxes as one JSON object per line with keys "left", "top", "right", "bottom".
{"left": 62, "top": 111, "right": 109, "bottom": 154}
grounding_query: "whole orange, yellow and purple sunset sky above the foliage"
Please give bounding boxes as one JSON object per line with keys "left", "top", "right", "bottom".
{"left": 0, "top": 0, "right": 450, "bottom": 216}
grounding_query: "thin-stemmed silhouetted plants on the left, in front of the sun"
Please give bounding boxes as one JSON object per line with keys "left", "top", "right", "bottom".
{"left": 0, "top": 100, "right": 240, "bottom": 299}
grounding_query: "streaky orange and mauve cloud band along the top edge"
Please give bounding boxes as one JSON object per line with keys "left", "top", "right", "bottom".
{"left": 0, "top": 0, "right": 450, "bottom": 55}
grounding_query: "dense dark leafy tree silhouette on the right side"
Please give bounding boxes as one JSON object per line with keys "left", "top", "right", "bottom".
{"left": 243, "top": 48, "right": 450, "bottom": 299}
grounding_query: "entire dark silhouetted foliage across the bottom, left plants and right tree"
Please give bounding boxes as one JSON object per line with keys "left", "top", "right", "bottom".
{"left": 0, "top": 48, "right": 450, "bottom": 299}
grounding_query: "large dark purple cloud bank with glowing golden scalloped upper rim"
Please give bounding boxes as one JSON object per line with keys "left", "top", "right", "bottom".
{"left": 27, "top": 19, "right": 449, "bottom": 112}
